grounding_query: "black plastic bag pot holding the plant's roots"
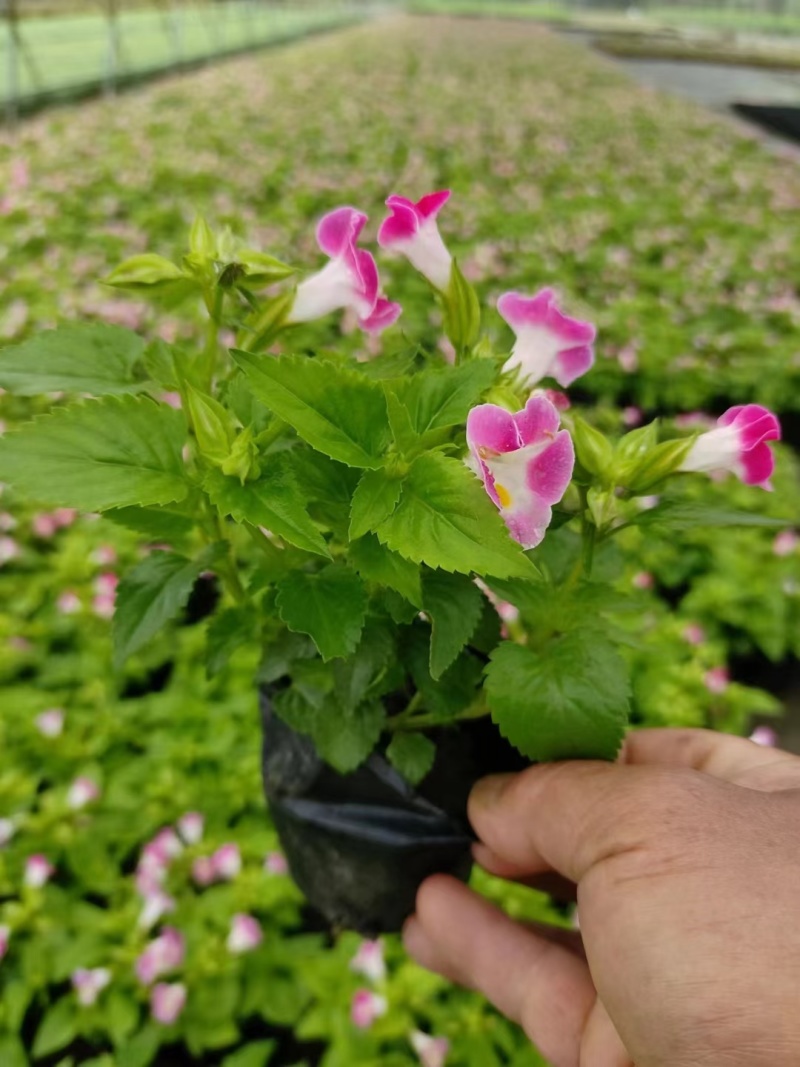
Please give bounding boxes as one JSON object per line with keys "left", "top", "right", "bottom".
{"left": 261, "top": 690, "right": 525, "bottom": 937}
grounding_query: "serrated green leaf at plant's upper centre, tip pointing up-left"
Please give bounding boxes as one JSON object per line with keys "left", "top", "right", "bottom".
{"left": 231, "top": 351, "right": 389, "bottom": 468}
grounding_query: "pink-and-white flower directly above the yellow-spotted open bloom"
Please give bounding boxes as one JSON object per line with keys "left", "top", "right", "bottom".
{"left": 497, "top": 289, "right": 596, "bottom": 388}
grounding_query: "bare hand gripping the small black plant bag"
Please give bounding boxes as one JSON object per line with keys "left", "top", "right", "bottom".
{"left": 404, "top": 730, "right": 800, "bottom": 1067}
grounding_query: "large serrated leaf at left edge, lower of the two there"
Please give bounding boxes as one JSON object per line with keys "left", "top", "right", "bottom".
{"left": 0, "top": 397, "right": 189, "bottom": 511}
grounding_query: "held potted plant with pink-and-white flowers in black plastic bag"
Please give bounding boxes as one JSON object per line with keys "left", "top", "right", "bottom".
{"left": 0, "top": 192, "right": 780, "bottom": 934}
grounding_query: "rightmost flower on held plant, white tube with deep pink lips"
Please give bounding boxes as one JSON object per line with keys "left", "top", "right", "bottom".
{"left": 681, "top": 403, "right": 781, "bottom": 489}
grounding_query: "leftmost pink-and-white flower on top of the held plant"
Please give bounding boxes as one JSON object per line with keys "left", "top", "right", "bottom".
{"left": 286, "top": 207, "right": 400, "bottom": 331}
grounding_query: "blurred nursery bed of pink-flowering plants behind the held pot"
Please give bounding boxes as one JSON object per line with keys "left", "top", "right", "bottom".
{"left": 0, "top": 18, "right": 800, "bottom": 1067}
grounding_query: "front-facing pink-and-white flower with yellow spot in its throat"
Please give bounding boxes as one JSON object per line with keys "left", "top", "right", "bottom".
{"left": 467, "top": 396, "right": 575, "bottom": 548}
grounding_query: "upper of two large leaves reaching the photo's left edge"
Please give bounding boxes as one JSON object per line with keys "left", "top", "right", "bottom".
{"left": 0, "top": 322, "right": 144, "bottom": 397}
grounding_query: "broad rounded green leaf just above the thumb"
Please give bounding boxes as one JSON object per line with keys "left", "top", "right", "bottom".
{"left": 485, "top": 631, "right": 630, "bottom": 761}
